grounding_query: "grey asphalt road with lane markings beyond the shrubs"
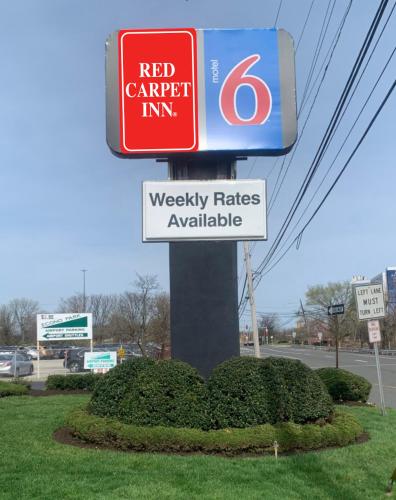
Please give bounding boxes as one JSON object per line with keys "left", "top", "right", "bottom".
{"left": 241, "top": 345, "right": 396, "bottom": 408}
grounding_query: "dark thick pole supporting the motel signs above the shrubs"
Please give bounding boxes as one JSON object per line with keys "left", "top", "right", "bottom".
{"left": 169, "top": 157, "right": 240, "bottom": 377}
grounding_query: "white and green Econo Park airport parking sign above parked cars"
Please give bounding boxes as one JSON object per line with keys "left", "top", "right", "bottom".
{"left": 37, "top": 313, "right": 92, "bottom": 341}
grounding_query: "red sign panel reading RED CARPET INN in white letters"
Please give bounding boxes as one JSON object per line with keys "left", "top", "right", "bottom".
{"left": 118, "top": 29, "right": 198, "bottom": 154}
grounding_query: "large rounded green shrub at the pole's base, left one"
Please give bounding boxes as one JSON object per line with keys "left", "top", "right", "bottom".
{"left": 89, "top": 358, "right": 208, "bottom": 428}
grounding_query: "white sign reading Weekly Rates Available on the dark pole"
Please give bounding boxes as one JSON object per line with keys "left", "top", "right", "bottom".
{"left": 143, "top": 180, "right": 267, "bottom": 241}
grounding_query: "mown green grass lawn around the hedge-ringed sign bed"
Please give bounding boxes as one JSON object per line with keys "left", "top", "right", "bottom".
{"left": 0, "top": 395, "right": 396, "bottom": 500}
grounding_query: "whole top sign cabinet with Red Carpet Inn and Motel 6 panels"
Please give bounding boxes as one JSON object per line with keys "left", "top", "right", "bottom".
{"left": 106, "top": 28, "right": 297, "bottom": 158}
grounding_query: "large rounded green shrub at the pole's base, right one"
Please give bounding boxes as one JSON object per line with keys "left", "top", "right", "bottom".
{"left": 208, "top": 357, "right": 333, "bottom": 428}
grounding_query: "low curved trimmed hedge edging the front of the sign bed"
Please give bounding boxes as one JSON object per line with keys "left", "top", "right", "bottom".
{"left": 66, "top": 410, "right": 363, "bottom": 455}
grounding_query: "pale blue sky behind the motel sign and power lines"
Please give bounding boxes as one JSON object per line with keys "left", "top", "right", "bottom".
{"left": 0, "top": 0, "right": 396, "bottom": 323}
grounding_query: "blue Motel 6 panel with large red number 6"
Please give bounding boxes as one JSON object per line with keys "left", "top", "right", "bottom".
{"left": 204, "top": 29, "right": 284, "bottom": 151}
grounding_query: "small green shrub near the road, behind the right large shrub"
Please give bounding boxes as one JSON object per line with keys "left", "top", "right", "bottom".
{"left": 316, "top": 368, "right": 371, "bottom": 403}
